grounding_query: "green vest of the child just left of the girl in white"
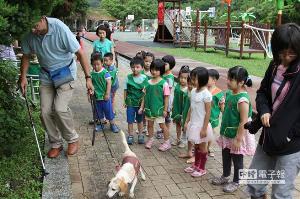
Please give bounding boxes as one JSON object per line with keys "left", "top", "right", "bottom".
{"left": 171, "top": 84, "right": 187, "bottom": 122}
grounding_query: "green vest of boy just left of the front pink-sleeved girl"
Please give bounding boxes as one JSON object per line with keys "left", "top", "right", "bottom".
{"left": 125, "top": 74, "right": 148, "bottom": 107}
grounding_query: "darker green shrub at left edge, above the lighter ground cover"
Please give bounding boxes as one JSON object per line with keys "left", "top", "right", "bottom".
{"left": 0, "top": 60, "right": 41, "bottom": 157}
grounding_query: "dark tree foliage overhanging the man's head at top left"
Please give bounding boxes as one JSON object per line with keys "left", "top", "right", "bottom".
{"left": 0, "top": 0, "right": 88, "bottom": 44}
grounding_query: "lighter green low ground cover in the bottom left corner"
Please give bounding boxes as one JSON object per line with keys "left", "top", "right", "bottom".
{"left": 0, "top": 113, "right": 44, "bottom": 199}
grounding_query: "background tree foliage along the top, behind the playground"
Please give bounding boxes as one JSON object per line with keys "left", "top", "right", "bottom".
{"left": 100, "top": 0, "right": 300, "bottom": 27}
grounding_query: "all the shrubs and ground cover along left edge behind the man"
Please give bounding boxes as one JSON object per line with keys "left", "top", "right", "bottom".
{"left": 0, "top": 60, "right": 44, "bottom": 199}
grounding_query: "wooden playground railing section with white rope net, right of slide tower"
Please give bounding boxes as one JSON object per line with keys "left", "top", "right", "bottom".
{"left": 193, "top": 21, "right": 272, "bottom": 58}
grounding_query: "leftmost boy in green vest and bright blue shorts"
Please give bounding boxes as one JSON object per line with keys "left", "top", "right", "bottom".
{"left": 91, "top": 53, "right": 119, "bottom": 133}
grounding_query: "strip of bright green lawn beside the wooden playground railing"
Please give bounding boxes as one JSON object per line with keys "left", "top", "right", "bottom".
{"left": 153, "top": 48, "right": 271, "bottom": 77}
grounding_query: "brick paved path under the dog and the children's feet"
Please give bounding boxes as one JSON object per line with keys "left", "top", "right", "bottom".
{"left": 68, "top": 39, "right": 300, "bottom": 199}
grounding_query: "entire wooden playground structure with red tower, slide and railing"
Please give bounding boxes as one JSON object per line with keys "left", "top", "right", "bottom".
{"left": 154, "top": 0, "right": 274, "bottom": 58}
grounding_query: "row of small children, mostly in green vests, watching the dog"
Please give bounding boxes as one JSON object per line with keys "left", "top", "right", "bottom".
{"left": 91, "top": 49, "right": 255, "bottom": 192}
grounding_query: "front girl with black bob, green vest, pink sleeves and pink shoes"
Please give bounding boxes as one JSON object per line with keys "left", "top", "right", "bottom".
{"left": 143, "top": 59, "right": 171, "bottom": 151}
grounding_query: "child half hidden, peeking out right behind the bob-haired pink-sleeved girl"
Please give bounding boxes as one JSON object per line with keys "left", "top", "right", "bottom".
{"left": 156, "top": 55, "right": 176, "bottom": 139}
